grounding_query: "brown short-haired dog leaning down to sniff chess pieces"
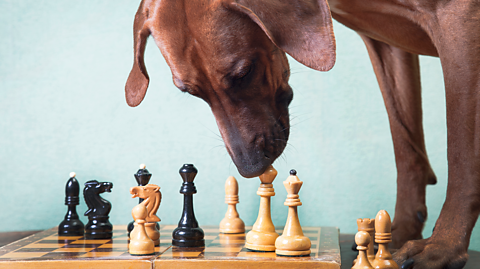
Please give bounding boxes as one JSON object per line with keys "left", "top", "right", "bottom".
{"left": 125, "top": 0, "right": 480, "bottom": 268}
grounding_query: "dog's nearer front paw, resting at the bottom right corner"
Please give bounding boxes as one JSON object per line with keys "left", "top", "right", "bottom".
{"left": 393, "top": 238, "right": 468, "bottom": 269}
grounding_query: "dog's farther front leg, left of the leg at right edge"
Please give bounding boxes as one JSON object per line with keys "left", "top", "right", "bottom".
{"left": 361, "top": 35, "right": 436, "bottom": 248}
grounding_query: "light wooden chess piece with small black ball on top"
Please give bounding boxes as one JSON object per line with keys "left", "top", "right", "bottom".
{"left": 275, "top": 169, "right": 312, "bottom": 256}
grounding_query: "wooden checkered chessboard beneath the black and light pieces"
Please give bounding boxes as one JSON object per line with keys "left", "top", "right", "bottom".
{"left": 0, "top": 225, "right": 340, "bottom": 269}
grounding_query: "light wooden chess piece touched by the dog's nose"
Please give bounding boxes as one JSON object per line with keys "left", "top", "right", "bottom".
{"left": 245, "top": 165, "right": 278, "bottom": 251}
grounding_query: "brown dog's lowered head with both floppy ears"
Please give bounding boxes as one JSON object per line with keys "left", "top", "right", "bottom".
{"left": 125, "top": 0, "right": 335, "bottom": 177}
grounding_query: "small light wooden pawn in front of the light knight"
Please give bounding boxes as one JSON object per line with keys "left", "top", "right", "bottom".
{"left": 128, "top": 204, "right": 155, "bottom": 255}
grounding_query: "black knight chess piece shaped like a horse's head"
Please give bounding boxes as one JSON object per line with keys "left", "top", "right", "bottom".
{"left": 83, "top": 180, "right": 113, "bottom": 239}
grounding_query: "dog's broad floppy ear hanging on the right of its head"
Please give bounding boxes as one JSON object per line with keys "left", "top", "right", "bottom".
{"left": 223, "top": 0, "right": 335, "bottom": 71}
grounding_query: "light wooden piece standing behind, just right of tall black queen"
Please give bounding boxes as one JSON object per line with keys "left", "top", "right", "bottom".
{"left": 220, "top": 176, "right": 245, "bottom": 234}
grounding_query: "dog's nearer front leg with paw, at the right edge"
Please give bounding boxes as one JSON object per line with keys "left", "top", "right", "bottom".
{"left": 395, "top": 7, "right": 480, "bottom": 269}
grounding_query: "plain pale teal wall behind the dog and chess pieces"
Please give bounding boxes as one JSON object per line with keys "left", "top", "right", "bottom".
{"left": 0, "top": 0, "right": 480, "bottom": 250}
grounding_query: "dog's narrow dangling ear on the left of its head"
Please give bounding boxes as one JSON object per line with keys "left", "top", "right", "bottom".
{"left": 125, "top": 5, "right": 150, "bottom": 106}
